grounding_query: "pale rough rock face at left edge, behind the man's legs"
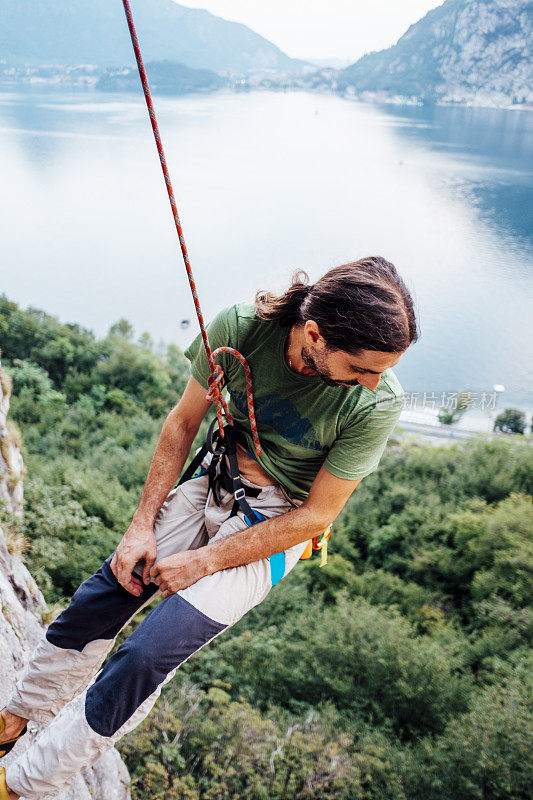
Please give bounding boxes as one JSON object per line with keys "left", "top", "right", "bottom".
{"left": 0, "top": 369, "right": 130, "bottom": 800}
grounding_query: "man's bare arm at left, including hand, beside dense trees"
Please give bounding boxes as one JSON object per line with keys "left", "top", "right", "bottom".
{"left": 111, "top": 378, "right": 211, "bottom": 596}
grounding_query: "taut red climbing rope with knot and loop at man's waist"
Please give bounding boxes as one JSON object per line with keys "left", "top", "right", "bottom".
{"left": 122, "top": 0, "right": 261, "bottom": 456}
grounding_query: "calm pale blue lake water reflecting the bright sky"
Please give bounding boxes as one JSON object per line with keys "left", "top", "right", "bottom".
{"left": 0, "top": 90, "right": 533, "bottom": 407}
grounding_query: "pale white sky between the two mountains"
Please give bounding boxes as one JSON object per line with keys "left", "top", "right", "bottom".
{"left": 180, "top": 0, "right": 442, "bottom": 62}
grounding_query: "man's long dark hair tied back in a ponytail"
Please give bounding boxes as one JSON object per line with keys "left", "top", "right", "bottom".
{"left": 255, "top": 256, "right": 419, "bottom": 355}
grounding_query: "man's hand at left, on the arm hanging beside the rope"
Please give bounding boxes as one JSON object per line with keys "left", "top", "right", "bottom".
{"left": 111, "top": 523, "right": 157, "bottom": 597}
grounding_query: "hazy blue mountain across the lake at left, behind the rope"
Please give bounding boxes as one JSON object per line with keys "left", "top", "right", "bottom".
{"left": 0, "top": 0, "right": 306, "bottom": 74}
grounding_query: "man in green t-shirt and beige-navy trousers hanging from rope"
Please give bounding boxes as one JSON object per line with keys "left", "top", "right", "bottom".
{"left": 0, "top": 257, "right": 418, "bottom": 800}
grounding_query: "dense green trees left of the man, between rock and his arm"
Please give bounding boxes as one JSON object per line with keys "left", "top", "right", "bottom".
{"left": 0, "top": 297, "right": 187, "bottom": 602}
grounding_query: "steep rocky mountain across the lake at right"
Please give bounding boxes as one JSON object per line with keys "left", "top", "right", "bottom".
{"left": 339, "top": 0, "right": 533, "bottom": 105}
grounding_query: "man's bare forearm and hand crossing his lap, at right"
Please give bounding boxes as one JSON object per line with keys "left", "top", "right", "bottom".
{"left": 150, "top": 467, "right": 361, "bottom": 597}
